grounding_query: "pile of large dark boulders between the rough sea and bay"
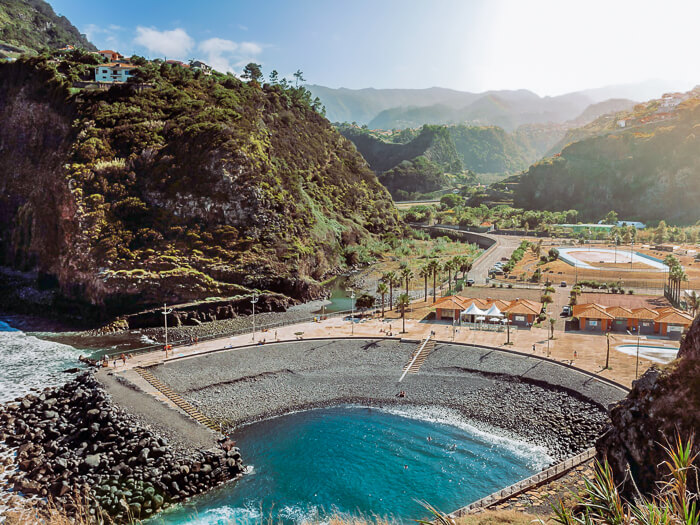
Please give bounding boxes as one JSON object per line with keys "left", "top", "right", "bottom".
{"left": 0, "top": 373, "right": 243, "bottom": 523}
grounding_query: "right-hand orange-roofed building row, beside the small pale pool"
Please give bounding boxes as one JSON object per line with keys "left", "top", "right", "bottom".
{"left": 573, "top": 303, "right": 693, "bottom": 339}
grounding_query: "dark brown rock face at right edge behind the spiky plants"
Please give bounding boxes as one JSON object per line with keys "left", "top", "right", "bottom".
{"left": 596, "top": 317, "right": 700, "bottom": 495}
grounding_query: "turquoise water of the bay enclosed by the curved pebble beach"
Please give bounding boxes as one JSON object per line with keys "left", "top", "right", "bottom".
{"left": 151, "top": 406, "right": 551, "bottom": 525}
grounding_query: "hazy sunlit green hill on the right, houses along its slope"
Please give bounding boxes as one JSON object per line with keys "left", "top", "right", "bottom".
{"left": 511, "top": 88, "right": 700, "bottom": 224}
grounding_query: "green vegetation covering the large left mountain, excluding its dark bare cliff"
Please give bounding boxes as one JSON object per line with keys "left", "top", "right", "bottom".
{"left": 0, "top": 54, "right": 403, "bottom": 310}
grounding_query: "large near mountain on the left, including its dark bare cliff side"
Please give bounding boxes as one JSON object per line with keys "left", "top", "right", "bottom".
{"left": 0, "top": 54, "right": 400, "bottom": 315}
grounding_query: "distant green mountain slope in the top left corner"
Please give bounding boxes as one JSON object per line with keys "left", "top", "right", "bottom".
{"left": 0, "top": 0, "right": 97, "bottom": 56}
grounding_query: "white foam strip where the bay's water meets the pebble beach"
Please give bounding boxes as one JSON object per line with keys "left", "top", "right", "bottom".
{"left": 372, "top": 406, "right": 554, "bottom": 471}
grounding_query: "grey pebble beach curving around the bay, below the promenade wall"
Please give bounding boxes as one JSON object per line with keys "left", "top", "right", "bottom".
{"left": 146, "top": 339, "right": 625, "bottom": 460}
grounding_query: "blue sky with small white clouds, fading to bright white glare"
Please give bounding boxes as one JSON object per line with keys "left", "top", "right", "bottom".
{"left": 49, "top": 0, "right": 700, "bottom": 96}
